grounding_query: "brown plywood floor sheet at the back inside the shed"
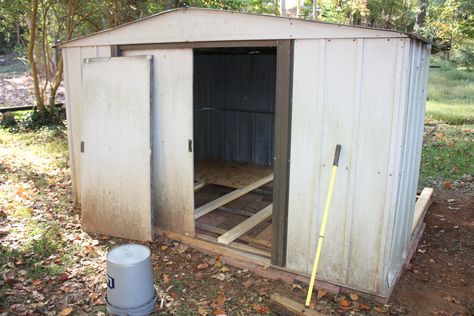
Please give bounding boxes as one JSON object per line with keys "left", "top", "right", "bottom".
{"left": 194, "top": 159, "right": 273, "bottom": 189}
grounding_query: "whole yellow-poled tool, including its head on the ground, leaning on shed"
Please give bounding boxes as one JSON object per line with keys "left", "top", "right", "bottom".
{"left": 270, "top": 144, "right": 341, "bottom": 316}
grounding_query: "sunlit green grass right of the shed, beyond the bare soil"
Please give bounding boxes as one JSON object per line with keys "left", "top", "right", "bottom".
{"left": 419, "top": 58, "right": 474, "bottom": 188}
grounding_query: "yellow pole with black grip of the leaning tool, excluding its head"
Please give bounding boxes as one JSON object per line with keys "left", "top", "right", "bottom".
{"left": 306, "top": 144, "right": 341, "bottom": 307}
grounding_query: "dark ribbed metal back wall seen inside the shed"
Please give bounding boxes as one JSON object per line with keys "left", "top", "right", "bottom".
{"left": 194, "top": 48, "right": 276, "bottom": 166}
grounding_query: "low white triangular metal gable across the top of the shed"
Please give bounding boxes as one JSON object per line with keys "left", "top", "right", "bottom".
{"left": 61, "top": 8, "right": 429, "bottom": 47}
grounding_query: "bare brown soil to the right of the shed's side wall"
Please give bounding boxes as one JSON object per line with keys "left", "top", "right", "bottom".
{"left": 390, "top": 190, "right": 474, "bottom": 315}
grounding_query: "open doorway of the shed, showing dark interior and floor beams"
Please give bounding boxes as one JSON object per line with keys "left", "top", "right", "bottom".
{"left": 193, "top": 47, "right": 277, "bottom": 258}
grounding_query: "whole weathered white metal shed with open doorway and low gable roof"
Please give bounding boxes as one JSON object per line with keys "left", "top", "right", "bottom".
{"left": 61, "top": 8, "right": 431, "bottom": 297}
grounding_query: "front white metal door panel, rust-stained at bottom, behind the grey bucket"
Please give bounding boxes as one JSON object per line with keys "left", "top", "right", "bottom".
{"left": 81, "top": 56, "right": 153, "bottom": 240}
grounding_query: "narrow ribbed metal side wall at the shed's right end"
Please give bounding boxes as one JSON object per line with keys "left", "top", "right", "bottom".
{"left": 382, "top": 40, "right": 430, "bottom": 287}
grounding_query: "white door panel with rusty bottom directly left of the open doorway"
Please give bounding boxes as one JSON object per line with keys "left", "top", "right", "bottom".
{"left": 124, "top": 49, "right": 194, "bottom": 235}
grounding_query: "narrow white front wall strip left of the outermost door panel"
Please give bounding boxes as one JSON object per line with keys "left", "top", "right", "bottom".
{"left": 63, "top": 46, "right": 110, "bottom": 205}
